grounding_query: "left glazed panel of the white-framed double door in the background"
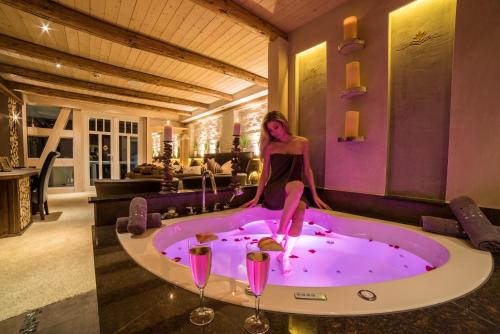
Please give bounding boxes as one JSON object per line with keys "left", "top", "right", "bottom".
{"left": 89, "top": 118, "right": 113, "bottom": 186}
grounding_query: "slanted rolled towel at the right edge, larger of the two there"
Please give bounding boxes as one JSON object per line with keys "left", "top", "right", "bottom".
{"left": 450, "top": 196, "right": 500, "bottom": 252}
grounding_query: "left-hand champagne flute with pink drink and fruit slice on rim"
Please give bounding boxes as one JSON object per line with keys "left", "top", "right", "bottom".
{"left": 188, "top": 239, "right": 214, "bottom": 326}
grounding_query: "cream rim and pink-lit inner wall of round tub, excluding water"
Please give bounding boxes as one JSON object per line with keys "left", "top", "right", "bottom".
{"left": 118, "top": 208, "right": 493, "bottom": 315}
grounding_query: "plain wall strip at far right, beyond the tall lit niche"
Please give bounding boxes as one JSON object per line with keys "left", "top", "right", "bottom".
{"left": 446, "top": 0, "right": 500, "bottom": 208}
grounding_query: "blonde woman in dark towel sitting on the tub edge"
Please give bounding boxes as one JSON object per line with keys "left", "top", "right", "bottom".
{"left": 241, "top": 111, "right": 331, "bottom": 276}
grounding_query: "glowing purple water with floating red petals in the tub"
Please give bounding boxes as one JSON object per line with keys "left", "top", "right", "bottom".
{"left": 163, "top": 220, "right": 433, "bottom": 287}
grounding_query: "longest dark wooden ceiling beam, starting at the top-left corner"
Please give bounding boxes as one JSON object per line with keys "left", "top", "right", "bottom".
{"left": 0, "top": 0, "right": 267, "bottom": 87}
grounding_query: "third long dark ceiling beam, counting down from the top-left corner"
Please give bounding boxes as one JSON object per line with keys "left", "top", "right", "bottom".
{"left": 0, "top": 63, "right": 208, "bottom": 109}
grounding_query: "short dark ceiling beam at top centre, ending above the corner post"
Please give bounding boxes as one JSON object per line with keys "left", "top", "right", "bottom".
{"left": 189, "top": 0, "right": 288, "bottom": 40}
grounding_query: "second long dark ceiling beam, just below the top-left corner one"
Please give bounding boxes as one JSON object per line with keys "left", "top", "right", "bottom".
{"left": 0, "top": 34, "right": 233, "bottom": 101}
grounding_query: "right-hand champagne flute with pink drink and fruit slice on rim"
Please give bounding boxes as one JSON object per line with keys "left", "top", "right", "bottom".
{"left": 243, "top": 243, "right": 270, "bottom": 334}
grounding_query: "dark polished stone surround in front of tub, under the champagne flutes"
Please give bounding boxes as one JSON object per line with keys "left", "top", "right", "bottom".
{"left": 94, "top": 226, "right": 500, "bottom": 334}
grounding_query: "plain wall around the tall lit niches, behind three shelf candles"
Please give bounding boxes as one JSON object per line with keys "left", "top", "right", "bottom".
{"left": 289, "top": 0, "right": 500, "bottom": 208}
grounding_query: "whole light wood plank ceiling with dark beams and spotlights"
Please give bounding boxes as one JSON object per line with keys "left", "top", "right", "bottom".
{"left": 0, "top": 0, "right": 344, "bottom": 120}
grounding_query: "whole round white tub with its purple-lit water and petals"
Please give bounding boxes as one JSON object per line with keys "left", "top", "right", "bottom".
{"left": 118, "top": 208, "right": 492, "bottom": 315}
